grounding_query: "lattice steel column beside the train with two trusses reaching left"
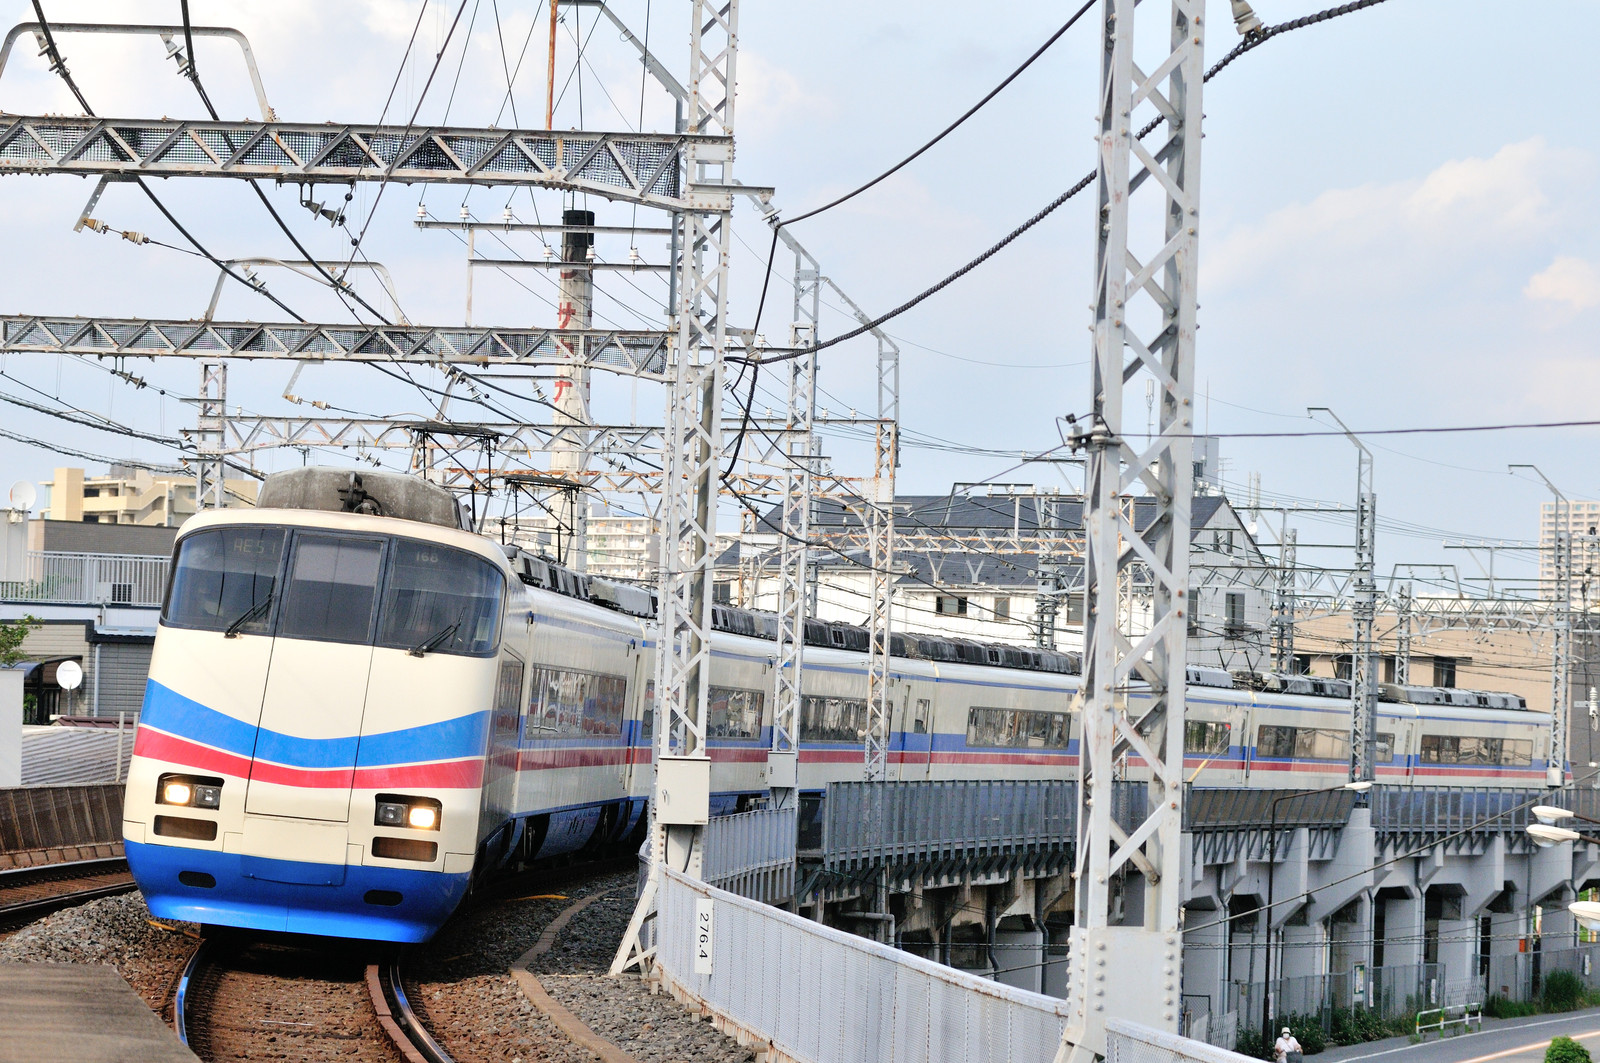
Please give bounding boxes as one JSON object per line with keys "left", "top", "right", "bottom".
{"left": 0, "top": 0, "right": 738, "bottom": 973}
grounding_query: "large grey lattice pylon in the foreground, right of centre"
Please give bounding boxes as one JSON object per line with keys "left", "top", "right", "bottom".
{"left": 1058, "top": 0, "right": 1206, "bottom": 1060}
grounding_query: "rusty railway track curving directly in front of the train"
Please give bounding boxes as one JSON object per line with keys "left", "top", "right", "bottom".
{"left": 173, "top": 938, "right": 453, "bottom": 1063}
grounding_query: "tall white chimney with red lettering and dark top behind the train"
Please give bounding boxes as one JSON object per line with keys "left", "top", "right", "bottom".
{"left": 550, "top": 209, "right": 595, "bottom": 572}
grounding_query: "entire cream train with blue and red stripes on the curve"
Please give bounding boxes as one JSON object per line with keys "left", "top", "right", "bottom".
{"left": 123, "top": 469, "right": 1549, "bottom": 941}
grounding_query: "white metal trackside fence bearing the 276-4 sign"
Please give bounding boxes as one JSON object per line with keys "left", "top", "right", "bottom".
{"left": 656, "top": 868, "right": 1068, "bottom": 1063}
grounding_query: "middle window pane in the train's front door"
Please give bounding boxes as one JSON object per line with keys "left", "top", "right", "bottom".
{"left": 278, "top": 535, "right": 384, "bottom": 642}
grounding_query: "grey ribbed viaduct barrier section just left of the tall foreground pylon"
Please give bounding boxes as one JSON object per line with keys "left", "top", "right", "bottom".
{"left": 822, "top": 780, "right": 1075, "bottom": 869}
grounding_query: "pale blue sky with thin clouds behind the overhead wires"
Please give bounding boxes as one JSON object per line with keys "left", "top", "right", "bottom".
{"left": 0, "top": 0, "right": 1600, "bottom": 592}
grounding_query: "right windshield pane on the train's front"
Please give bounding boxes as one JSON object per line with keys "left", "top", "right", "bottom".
{"left": 378, "top": 540, "right": 506, "bottom": 656}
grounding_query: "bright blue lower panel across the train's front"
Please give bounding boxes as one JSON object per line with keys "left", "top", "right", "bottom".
{"left": 125, "top": 842, "right": 472, "bottom": 943}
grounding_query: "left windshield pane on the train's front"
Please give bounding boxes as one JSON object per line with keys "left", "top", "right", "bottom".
{"left": 162, "top": 528, "right": 286, "bottom": 634}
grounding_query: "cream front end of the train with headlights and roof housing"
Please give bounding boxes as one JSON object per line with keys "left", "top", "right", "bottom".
{"left": 123, "top": 469, "right": 520, "bottom": 941}
